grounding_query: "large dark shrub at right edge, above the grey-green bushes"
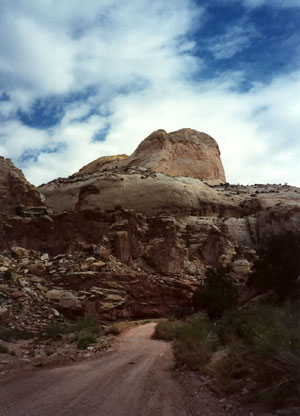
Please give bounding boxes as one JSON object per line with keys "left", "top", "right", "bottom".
{"left": 249, "top": 232, "right": 300, "bottom": 302}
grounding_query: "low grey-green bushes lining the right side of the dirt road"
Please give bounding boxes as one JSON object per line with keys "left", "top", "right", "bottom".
{"left": 155, "top": 302, "right": 300, "bottom": 406}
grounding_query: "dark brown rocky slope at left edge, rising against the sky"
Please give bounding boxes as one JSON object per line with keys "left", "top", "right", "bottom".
{"left": 0, "top": 156, "right": 45, "bottom": 215}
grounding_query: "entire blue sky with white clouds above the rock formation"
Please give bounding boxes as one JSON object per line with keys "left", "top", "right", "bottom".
{"left": 0, "top": 0, "right": 300, "bottom": 186}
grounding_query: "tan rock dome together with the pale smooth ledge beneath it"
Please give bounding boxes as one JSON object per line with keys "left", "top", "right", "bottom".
{"left": 39, "top": 129, "right": 227, "bottom": 215}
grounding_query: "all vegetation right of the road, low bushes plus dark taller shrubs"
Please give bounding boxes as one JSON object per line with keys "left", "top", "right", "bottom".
{"left": 154, "top": 233, "right": 300, "bottom": 407}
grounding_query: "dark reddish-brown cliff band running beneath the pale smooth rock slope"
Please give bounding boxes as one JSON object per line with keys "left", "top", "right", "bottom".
{"left": 0, "top": 186, "right": 300, "bottom": 274}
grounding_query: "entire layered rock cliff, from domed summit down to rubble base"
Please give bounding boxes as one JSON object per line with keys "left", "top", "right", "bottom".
{"left": 0, "top": 129, "right": 300, "bottom": 326}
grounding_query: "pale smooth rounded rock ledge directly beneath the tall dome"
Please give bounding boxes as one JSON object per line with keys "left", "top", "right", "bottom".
{"left": 39, "top": 168, "right": 237, "bottom": 215}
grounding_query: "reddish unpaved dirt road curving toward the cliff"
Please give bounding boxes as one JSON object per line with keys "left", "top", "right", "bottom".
{"left": 0, "top": 323, "right": 186, "bottom": 416}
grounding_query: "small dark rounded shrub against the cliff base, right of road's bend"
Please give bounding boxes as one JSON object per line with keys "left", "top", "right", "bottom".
{"left": 193, "top": 267, "right": 237, "bottom": 318}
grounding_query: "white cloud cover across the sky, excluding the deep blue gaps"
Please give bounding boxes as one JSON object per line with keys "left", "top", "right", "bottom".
{"left": 0, "top": 0, "right": 300, "bottom": 185}
